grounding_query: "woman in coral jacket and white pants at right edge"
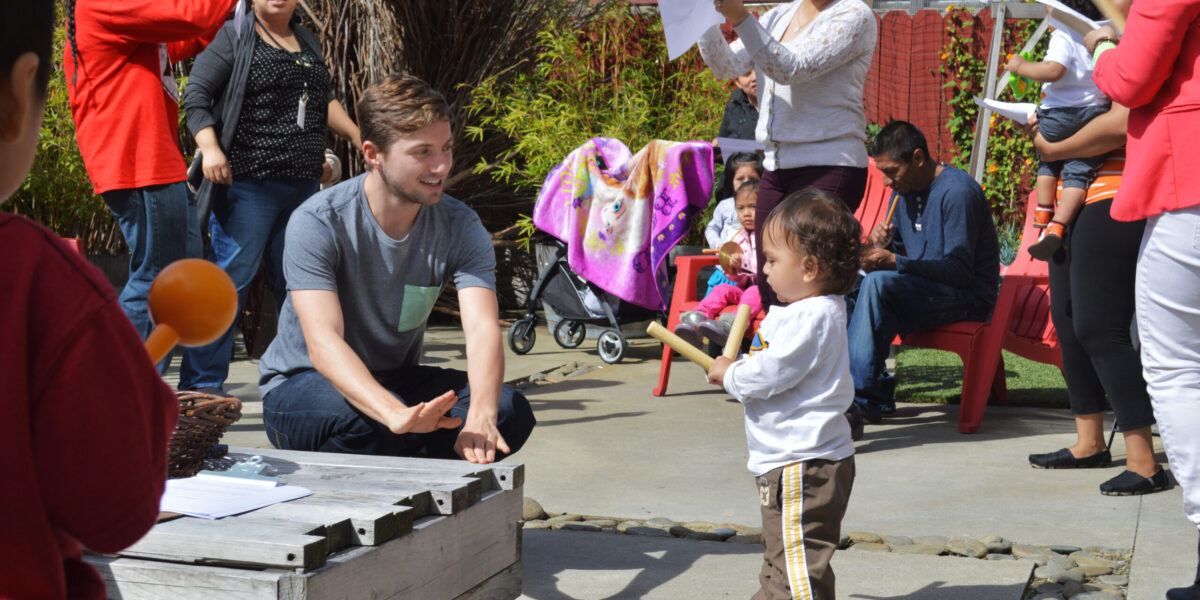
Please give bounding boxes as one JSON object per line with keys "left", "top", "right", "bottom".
{"left": 1086, "top": 0, "right": 1200, "bottom": 600}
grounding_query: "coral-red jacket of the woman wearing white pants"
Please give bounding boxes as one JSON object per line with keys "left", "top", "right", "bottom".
{"left": 1094, "top": 0, "right": 1200, "bottom": 221}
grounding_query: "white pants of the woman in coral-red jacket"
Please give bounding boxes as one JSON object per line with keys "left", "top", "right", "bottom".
{"left": 1136, "top": 205, "right": 1200, "bottom": 527}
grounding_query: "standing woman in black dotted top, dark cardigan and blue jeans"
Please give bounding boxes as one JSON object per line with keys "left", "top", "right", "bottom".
{"left": 179, "top": 0, "right": 361, "bottom": 395}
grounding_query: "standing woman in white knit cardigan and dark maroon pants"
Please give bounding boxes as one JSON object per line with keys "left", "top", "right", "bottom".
{"left": 698, "top": 0, "right": 877, "bottom": 305}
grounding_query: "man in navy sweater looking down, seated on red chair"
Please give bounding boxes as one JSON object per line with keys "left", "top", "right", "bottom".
{"left": 847, "top": 121, "right": 1000, "bottom": 424}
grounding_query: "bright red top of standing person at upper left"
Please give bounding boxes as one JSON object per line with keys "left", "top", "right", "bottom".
{"left": 64, "top": 0, "right": 233, "bottom": 193}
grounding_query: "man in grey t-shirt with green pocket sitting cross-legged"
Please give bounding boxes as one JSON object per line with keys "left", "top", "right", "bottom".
{"left": 259, "top": 76, "right": 535, "bottom": 463}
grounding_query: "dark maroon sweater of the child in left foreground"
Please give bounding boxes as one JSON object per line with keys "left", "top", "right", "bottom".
{"left": 0, "top": 214, "right": 179, "bottom": 600}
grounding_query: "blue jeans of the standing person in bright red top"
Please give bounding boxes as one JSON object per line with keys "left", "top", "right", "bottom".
{"left": 102, "top": 181, "right": 203, "bottom": 370}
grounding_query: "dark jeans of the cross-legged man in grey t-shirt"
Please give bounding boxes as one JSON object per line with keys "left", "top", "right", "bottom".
{"left": 263, "top": 366, "right": 536, "bottom": 458}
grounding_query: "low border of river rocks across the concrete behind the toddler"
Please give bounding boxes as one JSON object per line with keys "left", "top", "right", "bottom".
{"left": 521, "top": 498, "right": 1132, "bottom": 600}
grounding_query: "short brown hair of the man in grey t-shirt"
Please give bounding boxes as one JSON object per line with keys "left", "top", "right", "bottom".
{"left": 358, "top": 73, "right": 450, "bottom": 151}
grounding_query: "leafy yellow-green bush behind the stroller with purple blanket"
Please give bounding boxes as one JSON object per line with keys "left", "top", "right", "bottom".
{"left": 467, "top": 2, "right": 728, "bottom": 244}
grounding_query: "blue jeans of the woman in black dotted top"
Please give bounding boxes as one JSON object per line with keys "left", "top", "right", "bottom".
{"left": 179, "top": 179, "right": 319, "bottom": 390}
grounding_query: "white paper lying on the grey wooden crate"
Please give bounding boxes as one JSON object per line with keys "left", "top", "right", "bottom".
{"left": 158, "top": 478, "right": 312, "bottom": 518}
